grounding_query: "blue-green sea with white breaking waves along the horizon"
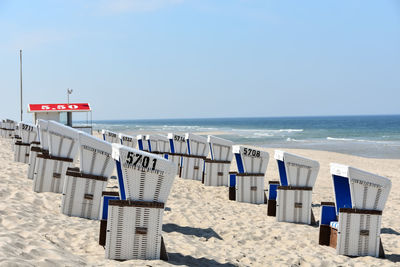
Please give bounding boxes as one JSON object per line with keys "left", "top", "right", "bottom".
{"left": 93, "top": 115, "right": 400, "bottom": 159}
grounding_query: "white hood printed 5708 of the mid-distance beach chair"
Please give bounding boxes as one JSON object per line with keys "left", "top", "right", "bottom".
{"left": 232, "top": 145, "right": 269, "bottom": 174}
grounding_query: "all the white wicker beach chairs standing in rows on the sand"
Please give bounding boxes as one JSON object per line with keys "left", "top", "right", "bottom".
{"left": 0, "top": 120, "right": 391, "bottom": 260}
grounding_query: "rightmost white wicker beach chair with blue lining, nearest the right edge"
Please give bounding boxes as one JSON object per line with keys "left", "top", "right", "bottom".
{"left": 319, "top": 163, "right": 392, "bottom": 258}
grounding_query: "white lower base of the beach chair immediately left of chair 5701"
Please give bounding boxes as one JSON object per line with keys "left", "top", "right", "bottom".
{"left": 61, "top": 172, "right": 108, "bottom": 220}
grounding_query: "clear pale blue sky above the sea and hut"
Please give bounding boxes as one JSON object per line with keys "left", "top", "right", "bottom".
{"left": 0, "top": 0, "right": 400, "bottom": 119}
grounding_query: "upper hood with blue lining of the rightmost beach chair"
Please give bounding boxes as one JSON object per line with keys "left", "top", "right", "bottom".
{"left": 330, "top": 163, "right": 392, "bottom": 214}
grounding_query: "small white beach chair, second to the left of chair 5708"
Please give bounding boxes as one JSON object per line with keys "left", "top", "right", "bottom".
{"left": 181, "top": 133, "right": 210, "bottom": 181}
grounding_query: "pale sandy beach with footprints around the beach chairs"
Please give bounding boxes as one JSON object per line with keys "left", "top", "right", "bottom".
{"left": 0, "top": 139, "right": 400, "bottom": 266}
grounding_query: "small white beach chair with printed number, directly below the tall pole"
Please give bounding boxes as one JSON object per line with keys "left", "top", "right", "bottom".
{"left": 14, "top": 122, "right": 38, "bottom": 163}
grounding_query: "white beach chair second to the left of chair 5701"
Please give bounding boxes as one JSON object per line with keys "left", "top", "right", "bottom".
{"left": 33, "top": 121, "right": 79, "bottom": 193}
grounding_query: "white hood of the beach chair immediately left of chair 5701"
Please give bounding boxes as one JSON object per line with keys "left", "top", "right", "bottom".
{"left": 79, "top": 132, "right": 115, "bottom": 178}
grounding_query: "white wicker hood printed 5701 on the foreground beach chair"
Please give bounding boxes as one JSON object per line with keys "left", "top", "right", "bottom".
{"left": 112, "top": 144, "right": 176, "bottom": 203}
